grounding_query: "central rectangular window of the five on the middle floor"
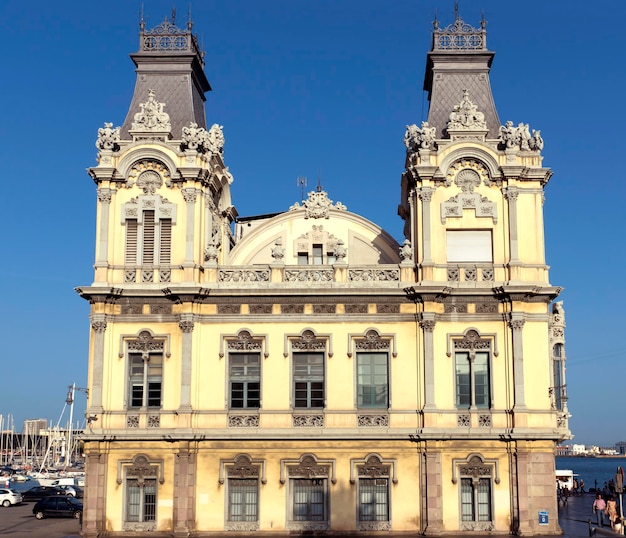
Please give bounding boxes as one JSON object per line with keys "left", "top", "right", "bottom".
{"left": 293, "top": 353, "right": 324, "bottom": 409}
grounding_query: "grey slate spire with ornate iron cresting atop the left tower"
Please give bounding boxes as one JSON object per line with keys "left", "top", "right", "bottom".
{"left": 121, "top": 14, "right": 211, "bottom": 139}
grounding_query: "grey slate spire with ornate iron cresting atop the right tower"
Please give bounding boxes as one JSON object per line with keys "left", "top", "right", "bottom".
{"left": 424, "top": 9, "right": 500, "bottom": 138}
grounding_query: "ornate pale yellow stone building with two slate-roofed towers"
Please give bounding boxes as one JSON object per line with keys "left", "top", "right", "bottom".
{"left": 77, "top": 10, "right": 570, "bottom": 537}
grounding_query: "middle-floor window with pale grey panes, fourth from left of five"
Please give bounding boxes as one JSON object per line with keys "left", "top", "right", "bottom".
{"left": 356, "top": 353, "right": 389, "bottom": 409}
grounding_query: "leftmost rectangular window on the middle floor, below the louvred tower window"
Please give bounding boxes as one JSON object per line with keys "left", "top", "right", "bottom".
{"left": 129, "top": 353, "right": 163, "bottom": 408}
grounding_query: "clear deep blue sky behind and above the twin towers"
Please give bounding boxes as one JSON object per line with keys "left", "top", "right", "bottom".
{"left": 0, "top": 0, "right": 626, "bottom": 445}
